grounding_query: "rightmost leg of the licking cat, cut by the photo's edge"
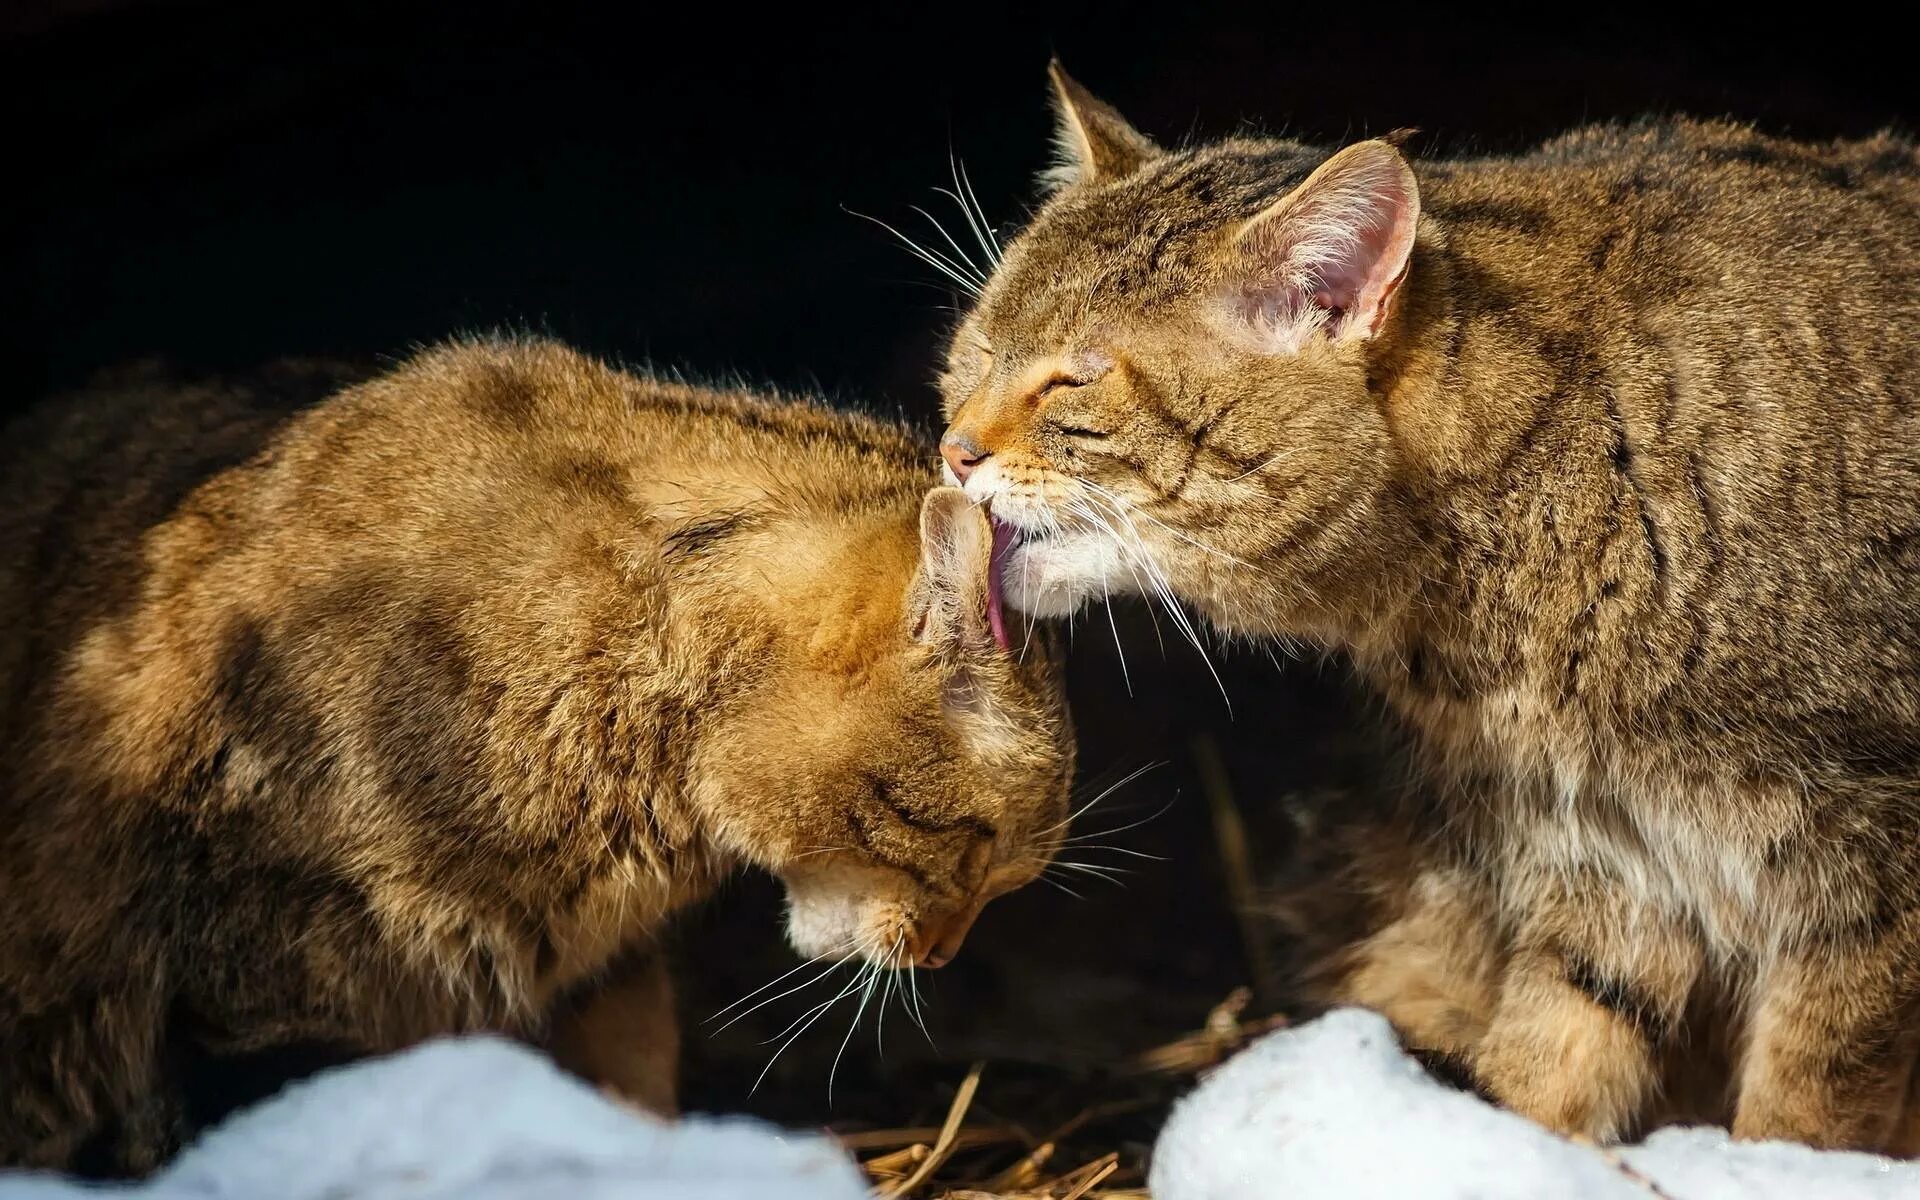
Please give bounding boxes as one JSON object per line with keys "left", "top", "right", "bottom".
{"left": 1734, "top": 929, "right": 1920, "bottom": 1150}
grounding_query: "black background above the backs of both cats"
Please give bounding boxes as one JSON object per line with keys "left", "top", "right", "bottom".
{"left": 0, "top": 0, "right": 1916, "bottom": 415}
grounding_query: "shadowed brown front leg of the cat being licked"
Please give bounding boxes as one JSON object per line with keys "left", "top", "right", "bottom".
{"left": 547, "top": 950, "right": 680, "bottom": 1117}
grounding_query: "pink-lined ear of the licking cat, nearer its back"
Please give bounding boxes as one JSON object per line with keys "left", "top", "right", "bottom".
{"left": 1229, "top": 140, "right": 1421, "bottom": 353}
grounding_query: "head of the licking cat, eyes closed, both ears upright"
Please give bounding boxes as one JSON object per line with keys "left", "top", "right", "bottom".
{"left": 941, "top": 63, "right": 1419, "bottom": 628}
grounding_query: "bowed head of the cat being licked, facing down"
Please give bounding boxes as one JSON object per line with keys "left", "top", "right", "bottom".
{"left": 698, "top": 488, "right": 1073, "bottom": 966}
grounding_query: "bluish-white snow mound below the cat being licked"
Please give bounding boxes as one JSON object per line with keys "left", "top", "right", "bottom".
{"left": 0, "top": 1037, "right": 868, "bottom": 1200}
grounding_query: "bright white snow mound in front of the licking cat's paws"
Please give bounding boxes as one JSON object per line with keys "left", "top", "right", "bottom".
{"left": 1152, "top": 1010, "right": 1920, "bottom": 1200}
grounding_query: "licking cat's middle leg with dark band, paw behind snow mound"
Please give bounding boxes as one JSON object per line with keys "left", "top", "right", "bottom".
{"left": 1475, "top": 877, "right": 1703, "bottom": 1142}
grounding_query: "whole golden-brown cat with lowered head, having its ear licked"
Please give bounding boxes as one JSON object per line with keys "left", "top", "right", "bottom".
{"left": 0, "top": 342, "right": 1073, "bottom": 1169}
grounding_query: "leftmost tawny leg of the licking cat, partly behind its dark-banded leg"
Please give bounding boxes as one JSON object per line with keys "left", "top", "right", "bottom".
{"left": 1321, "top": 866, "right": 1503, "bottom": 1075}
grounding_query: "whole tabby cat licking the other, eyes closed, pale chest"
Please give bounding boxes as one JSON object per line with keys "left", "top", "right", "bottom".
{"left": 943, "top": 69, "right": 1920, "bottom": 1146}
